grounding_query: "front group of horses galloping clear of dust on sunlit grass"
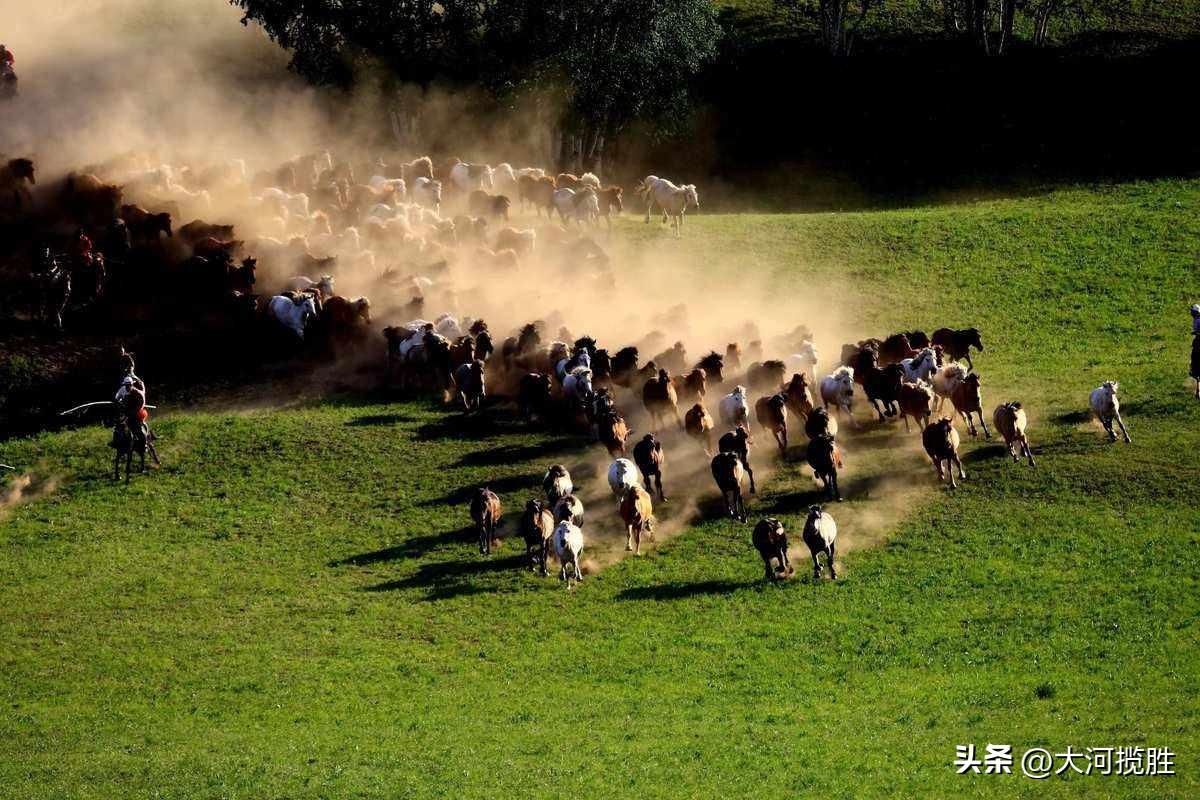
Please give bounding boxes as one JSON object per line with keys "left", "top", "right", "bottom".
{"left": 384, "top": 315, "right": 1128, "bottom": 585}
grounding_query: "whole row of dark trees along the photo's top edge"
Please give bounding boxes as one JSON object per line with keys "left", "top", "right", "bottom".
{"left": 230, "top": 0, "right": 1171, "bottom": 170}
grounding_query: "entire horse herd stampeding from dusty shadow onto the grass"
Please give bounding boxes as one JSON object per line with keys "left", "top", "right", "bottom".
{"left": 0, "top": 152, "right": 1129, "bottom": 583}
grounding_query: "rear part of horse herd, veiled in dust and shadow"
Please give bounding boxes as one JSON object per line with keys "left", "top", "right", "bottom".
{"left": 0, "top": 151, "right": 700, "bottom": 350}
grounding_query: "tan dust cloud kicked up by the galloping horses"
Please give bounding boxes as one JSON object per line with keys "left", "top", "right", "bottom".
{"left": 0, "top": 0, "right": 936, "bottom": 571}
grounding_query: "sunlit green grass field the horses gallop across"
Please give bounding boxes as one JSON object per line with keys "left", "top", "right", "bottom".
{"left": 7, "top": 181, "right": 1200, "bottom": 800}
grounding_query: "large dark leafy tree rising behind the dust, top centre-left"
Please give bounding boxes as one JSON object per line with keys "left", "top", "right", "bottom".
{"left": 232, "top": 0, "right": 721, "bottom": 168}
